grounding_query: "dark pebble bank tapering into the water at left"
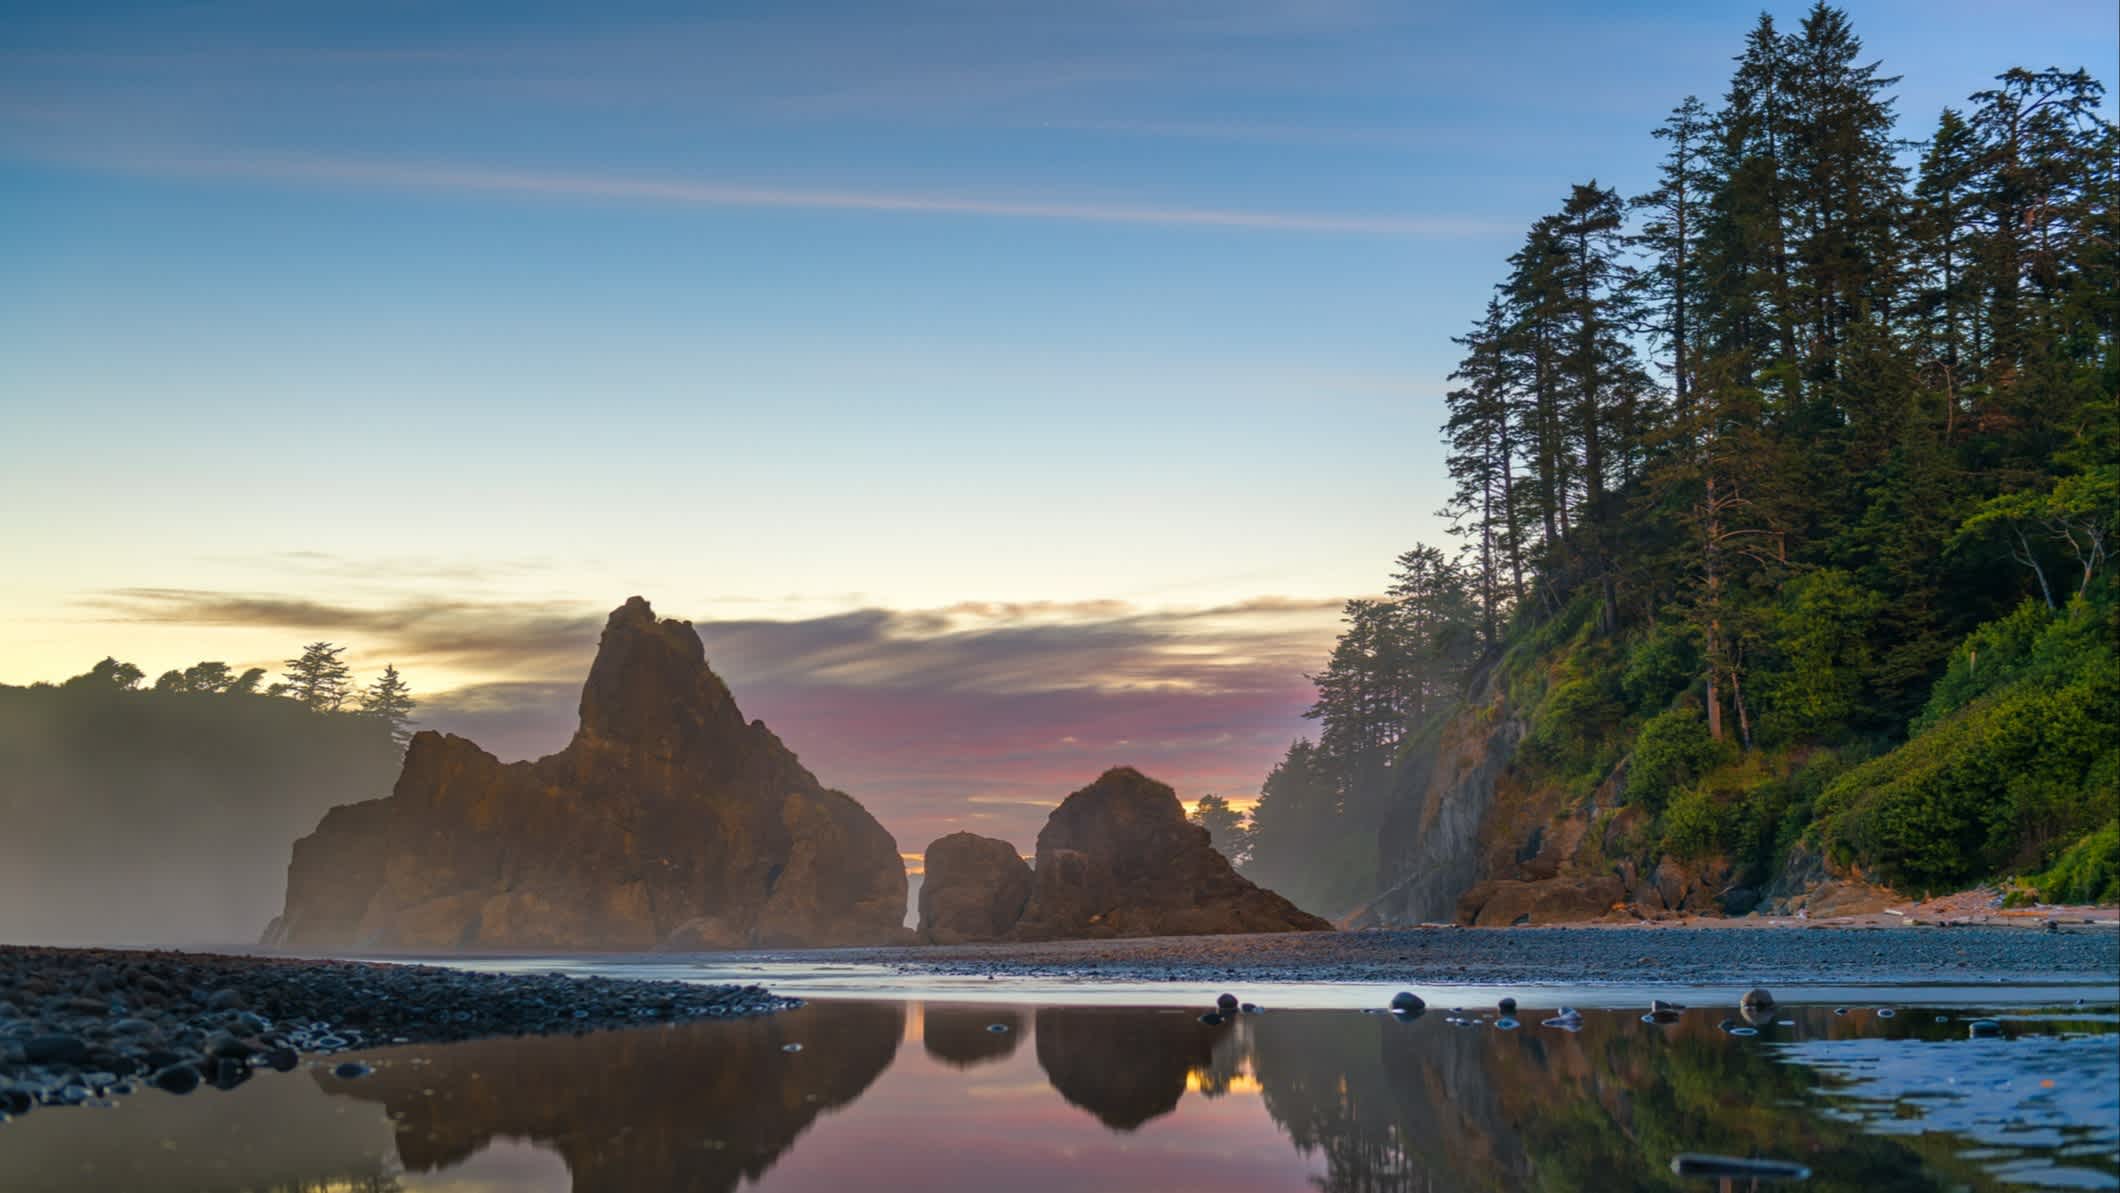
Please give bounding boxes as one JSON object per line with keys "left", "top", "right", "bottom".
{"left": 0, "top": 945, "right": 801, "bottom": 1119}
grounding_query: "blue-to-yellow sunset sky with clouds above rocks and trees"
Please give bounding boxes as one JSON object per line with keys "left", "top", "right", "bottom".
{"left": 0, "top": 0, "right": 2120, "bottom": 852}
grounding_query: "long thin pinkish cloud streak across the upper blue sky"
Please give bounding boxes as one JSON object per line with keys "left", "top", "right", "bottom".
{"left": 40, "top": 148, "right": 1507, "bottom": 237}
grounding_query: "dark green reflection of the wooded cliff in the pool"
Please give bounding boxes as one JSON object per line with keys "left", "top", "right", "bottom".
{"left": 1246, "top": 1011, "right": 1942, "bottom": 1193}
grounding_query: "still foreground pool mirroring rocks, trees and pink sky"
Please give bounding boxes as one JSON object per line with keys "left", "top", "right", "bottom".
{"left": 0, "top": 998, "right": 2120, "bottom": 1193}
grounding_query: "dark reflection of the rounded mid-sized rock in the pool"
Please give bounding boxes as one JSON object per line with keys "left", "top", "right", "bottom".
{"left": 1037, "top": 1007, "right": 1234, "bottom": 1132}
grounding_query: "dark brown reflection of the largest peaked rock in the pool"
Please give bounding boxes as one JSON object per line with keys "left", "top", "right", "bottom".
{"left": 312, "top": 1002, "right": 905, "bottom": 1193}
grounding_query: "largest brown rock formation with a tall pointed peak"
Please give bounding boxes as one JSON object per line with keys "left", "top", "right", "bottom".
{"left": 267, "top": 598, "right": 905, "bottom": 949}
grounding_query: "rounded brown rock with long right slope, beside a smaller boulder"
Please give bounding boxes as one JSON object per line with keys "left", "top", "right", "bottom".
{"left": 1013, "top": 767, "right": 1331, "bottom": 945}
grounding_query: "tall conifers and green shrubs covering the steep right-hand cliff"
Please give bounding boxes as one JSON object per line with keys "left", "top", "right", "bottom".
{"left": 1244, "top": 4, "right": 2120, "bottom": 911}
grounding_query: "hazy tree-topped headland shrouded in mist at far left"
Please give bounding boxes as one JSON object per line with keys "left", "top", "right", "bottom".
{"left": 0, "top": 642, "right": 413, "bottom": 943}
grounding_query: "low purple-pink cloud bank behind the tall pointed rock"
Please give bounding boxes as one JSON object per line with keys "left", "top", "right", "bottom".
{"left": 95, "top": 589, "right": 1338, "bottom": 848}
